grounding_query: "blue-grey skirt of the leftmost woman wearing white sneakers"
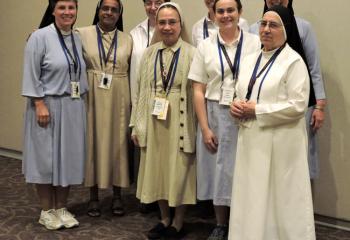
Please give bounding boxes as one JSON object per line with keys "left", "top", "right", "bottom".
{"left": 22, "top": 96, "right": 86, "bottom": 187}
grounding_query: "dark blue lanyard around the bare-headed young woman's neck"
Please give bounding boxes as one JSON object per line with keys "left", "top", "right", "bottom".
{"left": 217, "top": 31, "right": 243, "bottom": 82}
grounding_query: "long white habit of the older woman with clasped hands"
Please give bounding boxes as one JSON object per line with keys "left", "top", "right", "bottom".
{"left": 229, "top": 45, "right": 315, "bottom": 240}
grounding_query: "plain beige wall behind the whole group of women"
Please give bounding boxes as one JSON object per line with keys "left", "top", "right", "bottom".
{"left": 0, "top": 0, "right": 350, "bottom": 220}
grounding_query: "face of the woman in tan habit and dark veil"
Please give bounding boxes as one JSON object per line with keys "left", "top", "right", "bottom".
{"left": 98, "top": 0, "right": 120, "bottom": 31}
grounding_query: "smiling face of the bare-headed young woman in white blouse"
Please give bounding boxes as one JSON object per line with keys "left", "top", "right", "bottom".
{"left": 215, "top": 0, "right": 242, "bottom": 30}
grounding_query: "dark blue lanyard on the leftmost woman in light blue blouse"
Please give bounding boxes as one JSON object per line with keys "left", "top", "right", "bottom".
{"left": 54, "top": 24, "right": 81, "bottom": 82}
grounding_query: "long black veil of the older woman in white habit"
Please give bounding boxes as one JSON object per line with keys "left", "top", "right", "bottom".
{"left": 264, "top": 0, "right": 316, "bottom": 106}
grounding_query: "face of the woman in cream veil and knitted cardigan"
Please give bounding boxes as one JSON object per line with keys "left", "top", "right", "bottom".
{"left": 156, "top": 7, "right": 181, "bottom": 46}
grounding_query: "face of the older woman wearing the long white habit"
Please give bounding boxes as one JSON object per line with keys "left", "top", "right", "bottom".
{"left": 259, "top": 11, "right": 286, "bottom": 51}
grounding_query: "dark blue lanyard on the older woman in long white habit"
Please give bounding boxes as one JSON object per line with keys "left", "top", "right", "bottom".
{"left": 245, "top": 44, "right": 285, "bottom": 103}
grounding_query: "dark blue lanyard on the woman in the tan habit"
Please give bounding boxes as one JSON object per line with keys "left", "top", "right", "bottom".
{"left": 96, "top": 25, "right": 118, "bottom": 72}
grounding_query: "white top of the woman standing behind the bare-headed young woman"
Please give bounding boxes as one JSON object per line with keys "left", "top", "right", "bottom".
{"left": 192, "top": 16, "right": 249, "bottom": 47}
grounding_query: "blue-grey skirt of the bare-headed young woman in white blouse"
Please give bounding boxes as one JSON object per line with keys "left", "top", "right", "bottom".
{"left": 197, "top": 101, "right": 238, "bottom": 207}
